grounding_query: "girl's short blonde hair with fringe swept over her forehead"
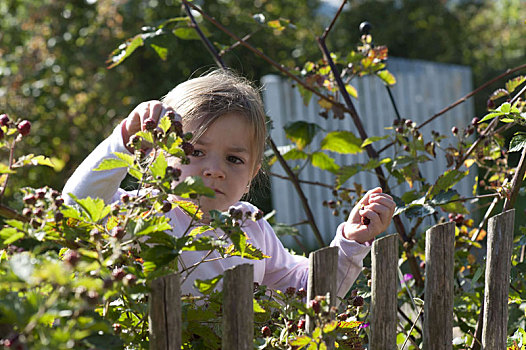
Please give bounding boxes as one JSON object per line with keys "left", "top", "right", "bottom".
{"left": 162, "top": 69, "right": 267, "bottom": 175}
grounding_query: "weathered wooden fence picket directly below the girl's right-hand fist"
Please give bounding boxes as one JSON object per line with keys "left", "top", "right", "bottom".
{"left": 369, "top": 234, "right": 398, "bottom": 350}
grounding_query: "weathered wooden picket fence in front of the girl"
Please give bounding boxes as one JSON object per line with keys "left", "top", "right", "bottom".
{"left": 150, "top": 209, "right": 515, "bottom": 350}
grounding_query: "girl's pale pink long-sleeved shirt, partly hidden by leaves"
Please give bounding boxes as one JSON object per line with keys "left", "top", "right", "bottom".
{"left": 63, "top": 125, "right": 371, "bottom": 297}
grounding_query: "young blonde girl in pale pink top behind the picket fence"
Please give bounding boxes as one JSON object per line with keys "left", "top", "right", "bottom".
{"left": 63, "top": 70, "right": 395, "bottom": 297}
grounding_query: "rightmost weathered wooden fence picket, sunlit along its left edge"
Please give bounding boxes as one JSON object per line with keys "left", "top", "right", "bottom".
{"left": 482, "top": 209, "right": 515, "bottom": 350}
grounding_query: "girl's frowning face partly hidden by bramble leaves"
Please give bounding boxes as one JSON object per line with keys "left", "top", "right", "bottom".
{"left": 177, "top": 112, "right": 259, "bottom": 214}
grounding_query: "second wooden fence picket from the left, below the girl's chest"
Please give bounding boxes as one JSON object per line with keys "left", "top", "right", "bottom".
{"left": 221, "top": 264, "right": 254, "bottom": 350}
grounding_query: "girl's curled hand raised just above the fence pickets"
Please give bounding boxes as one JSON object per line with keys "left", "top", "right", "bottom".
{"left": 343, "top": 187, "right": 396, "bottom": 244}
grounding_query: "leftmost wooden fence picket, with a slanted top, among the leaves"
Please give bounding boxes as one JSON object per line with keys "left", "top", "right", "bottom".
{"left": 148, "top": 274, "right": 182, "bottom": 350}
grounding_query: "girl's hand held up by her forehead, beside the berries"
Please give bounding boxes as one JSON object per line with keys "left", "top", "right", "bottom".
{"left": 122, "top": 100, "right": 175, "bottom": 152}
